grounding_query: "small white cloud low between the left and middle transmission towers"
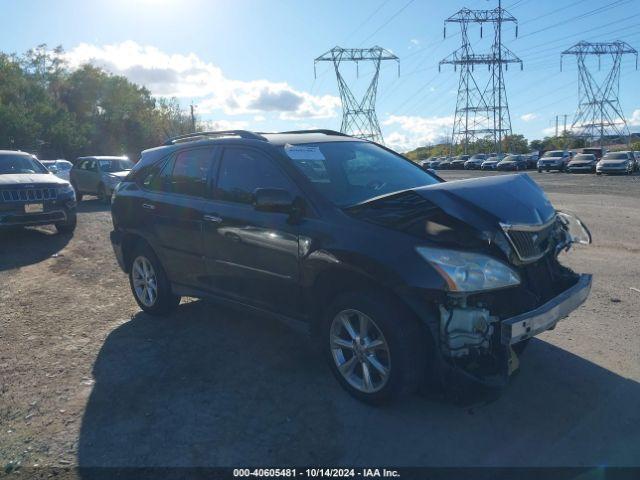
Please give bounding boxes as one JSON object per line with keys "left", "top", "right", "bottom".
{"left": 382, "top": 115, "right": 453, "bottom": 151}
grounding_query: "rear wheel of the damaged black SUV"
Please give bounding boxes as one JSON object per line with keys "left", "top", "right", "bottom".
{"left": 129, "top": 246, "right": 180, "bottom": 315}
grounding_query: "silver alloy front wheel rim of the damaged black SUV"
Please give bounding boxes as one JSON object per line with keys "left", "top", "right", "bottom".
{"left": 329, "top": 310, "right": 391, "bottom": 393}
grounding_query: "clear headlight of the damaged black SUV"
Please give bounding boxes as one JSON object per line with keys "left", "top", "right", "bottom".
{"left": 416, "top": 247, "right": 520, "bottom": 292}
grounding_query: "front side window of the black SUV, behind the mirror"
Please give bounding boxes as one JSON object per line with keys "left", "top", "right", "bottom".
{"left": 217, "top": 148, "right": 296, "bottom": 203}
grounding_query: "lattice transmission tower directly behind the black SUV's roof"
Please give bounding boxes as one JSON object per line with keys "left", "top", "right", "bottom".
{"left": 313, "top": 46, "right": 400, "bottom": 143}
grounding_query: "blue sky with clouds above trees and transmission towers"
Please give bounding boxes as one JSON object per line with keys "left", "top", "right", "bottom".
{"left": 0, "top": 0, "right": 640, "bottom": 151}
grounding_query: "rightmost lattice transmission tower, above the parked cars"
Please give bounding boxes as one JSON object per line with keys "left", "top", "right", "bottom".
{"left": 560, "top": 41, "right": 638, "bottom": 146}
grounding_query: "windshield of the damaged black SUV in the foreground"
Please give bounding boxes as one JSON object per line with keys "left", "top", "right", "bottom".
{"left": 282, "top": 142, "right": 438, "bottom": 207}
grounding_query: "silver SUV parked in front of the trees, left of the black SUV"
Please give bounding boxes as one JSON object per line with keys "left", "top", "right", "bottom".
{"left": 70, "top": 156, "right": 133, "bottom": 202}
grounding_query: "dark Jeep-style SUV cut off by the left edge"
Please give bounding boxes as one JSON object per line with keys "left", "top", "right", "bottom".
{"left": 0, "top": 150, "right": 76, "bottom": 233}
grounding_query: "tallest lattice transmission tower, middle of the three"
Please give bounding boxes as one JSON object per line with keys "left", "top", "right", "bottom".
{"left": 438, "top": 1, "right": 522, "bottom": 153}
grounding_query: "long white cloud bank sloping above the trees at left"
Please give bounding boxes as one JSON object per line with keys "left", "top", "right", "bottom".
{"left": 65, "top": 41, "right": 340, "bottom": 119}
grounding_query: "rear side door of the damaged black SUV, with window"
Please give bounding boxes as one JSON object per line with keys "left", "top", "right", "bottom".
{"left": 136, "top": 146, "right": 215, "bottom": 289}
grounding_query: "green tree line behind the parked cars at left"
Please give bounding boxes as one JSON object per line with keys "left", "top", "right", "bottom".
{"left": 0, "top": 45, "right": 194, "bottom": 160}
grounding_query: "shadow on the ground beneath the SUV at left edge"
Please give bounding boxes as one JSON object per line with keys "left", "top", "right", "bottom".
{"left": 0, "top": 227, "right": 73, "bottom": 272}
